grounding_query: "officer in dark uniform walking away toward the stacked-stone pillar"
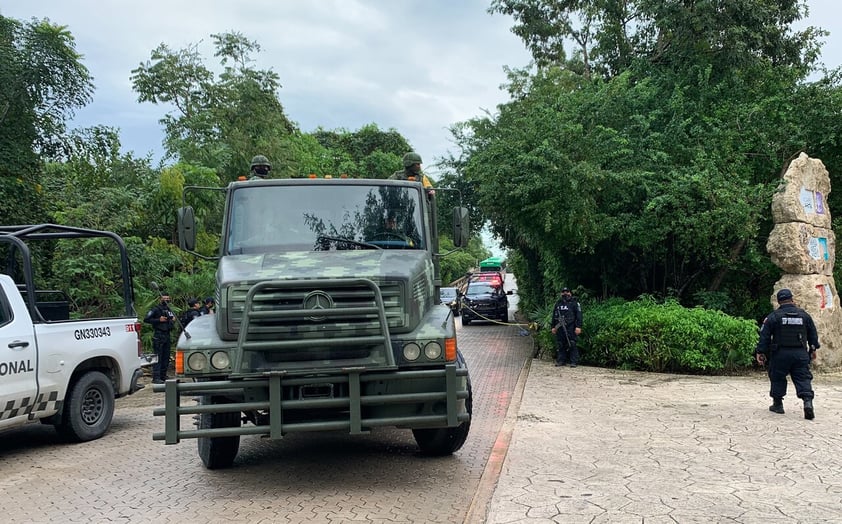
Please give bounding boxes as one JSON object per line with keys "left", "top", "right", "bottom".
{"left": 754, "top": 289, "right": 820, "bottom": 420}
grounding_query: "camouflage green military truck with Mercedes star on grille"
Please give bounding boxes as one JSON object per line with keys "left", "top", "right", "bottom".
{"left": 153, "top": 178, "right": 472, "bottom": 469}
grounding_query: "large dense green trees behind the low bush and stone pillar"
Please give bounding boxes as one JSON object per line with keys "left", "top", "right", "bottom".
{"left": 448, "top": 0, "right": 842, "bottom": 324}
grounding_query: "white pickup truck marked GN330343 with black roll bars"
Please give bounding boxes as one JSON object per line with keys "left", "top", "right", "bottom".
{"left": 0, "top": 224, "right": 151, "bottom": 442}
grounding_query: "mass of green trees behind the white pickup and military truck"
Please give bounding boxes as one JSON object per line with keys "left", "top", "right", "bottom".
{"left": 0, "top": 21, "right": 480, "bottom": 342}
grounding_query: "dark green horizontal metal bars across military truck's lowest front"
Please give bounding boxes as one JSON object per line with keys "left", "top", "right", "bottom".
{"left": 152, "top": 363, "right": 470, "bottom": 444}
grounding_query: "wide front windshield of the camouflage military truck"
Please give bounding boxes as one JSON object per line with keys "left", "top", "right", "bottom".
{"left": 225, "top": 182, "right": 427, "bottom": 254}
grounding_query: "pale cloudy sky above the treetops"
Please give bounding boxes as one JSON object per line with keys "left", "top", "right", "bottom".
{"left": 0, "top": 0, "right": 842, "bottom": 178}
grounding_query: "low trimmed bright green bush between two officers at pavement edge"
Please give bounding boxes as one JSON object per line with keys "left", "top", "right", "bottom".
{"left": 579, "top": 297, "right": 757, "bottom": 373}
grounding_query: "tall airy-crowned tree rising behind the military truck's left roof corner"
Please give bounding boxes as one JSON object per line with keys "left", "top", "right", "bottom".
{"left": 131, "top": 32, "right": 297, "bottom": 182}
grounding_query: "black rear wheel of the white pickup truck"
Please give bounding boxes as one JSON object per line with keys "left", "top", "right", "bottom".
{"left": 55, "top": 371, "right": 114, "bottom": 442}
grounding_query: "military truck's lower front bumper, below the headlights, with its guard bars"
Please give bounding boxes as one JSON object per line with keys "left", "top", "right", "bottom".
{"left": 152, "top": 362, "right": 470, "bottom": 444}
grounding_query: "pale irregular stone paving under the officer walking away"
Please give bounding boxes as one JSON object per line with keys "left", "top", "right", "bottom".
{"left": 484, "top": 360, "right": 842, "bottom": 524}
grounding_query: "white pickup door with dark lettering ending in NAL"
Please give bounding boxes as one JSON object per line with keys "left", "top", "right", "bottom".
{"left": 0, "top": 275, "right": 38, "bottom": 430}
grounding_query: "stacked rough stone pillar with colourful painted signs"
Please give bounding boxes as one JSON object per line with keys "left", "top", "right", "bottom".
{"left": 766, "top": 153, "right": 842, "bottom": 367}
